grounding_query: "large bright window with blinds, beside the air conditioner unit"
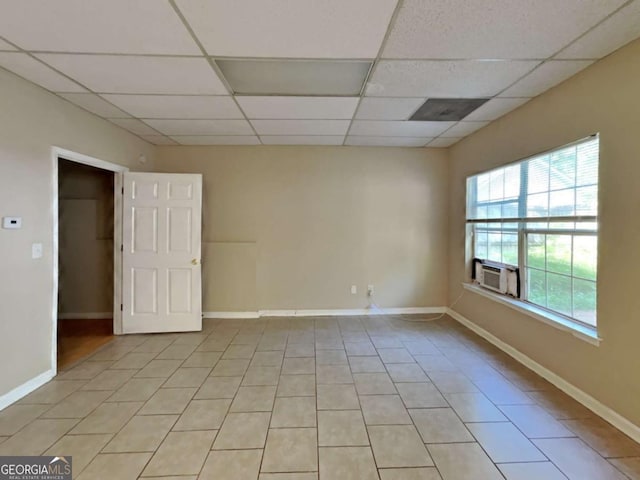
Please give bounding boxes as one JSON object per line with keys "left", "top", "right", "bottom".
{"left": 467, "top": 135, "right": 599, "bottom": 327}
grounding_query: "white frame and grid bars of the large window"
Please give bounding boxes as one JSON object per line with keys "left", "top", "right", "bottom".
{"left": 465, "top": 133, "right": 600, "bottom": 332}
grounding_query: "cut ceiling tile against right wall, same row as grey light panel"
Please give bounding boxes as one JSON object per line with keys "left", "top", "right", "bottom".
{"left": 500, "top": 60, "right": 593, "bottom": 97}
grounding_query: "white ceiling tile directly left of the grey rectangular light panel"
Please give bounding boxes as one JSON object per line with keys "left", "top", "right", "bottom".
{"left": 37, "top": 54, "right": 227, "bottom": 95}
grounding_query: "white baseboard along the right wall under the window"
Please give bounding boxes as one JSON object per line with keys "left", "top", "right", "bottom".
{"left": 447, "top": 308, "right": 640, "bottom": 442}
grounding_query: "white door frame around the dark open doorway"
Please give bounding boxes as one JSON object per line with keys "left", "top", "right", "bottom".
{"left": 51, "top": 147, "right": 129, "bottom": 375}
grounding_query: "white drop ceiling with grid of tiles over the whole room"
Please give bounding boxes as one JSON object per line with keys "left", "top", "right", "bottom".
{"left": 0, "top": 0, "right": 640, "bottom": 147}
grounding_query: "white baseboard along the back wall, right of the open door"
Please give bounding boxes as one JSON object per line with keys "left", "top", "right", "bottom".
{"left": 202, "top": 307, "right": 447, "bottom": 318}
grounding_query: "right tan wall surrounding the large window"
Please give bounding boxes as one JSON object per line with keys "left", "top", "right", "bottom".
{"left": 449, "top": 41, "right": 640, "bottom": 425}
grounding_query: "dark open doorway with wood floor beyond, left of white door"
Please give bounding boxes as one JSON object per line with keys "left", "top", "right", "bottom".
{"left": 57, "top": 157, "right": 115, "bottom": 369}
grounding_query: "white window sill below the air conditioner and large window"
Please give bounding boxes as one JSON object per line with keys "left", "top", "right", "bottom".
{"left": 462, "top": 283, "right": 602, "bottom": 346}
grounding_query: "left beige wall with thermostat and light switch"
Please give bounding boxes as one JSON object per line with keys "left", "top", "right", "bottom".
{"left": 0, "top": 69, "right": 155, "bottom": 396}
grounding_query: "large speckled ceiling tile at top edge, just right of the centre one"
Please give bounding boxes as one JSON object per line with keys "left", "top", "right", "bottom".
{"left": 383, "top": 0, "right": 625, "bottom": 59}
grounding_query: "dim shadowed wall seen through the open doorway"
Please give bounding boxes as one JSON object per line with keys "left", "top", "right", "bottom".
{"left": 58, "top": 160, "right": 114, "bottom": 318}
